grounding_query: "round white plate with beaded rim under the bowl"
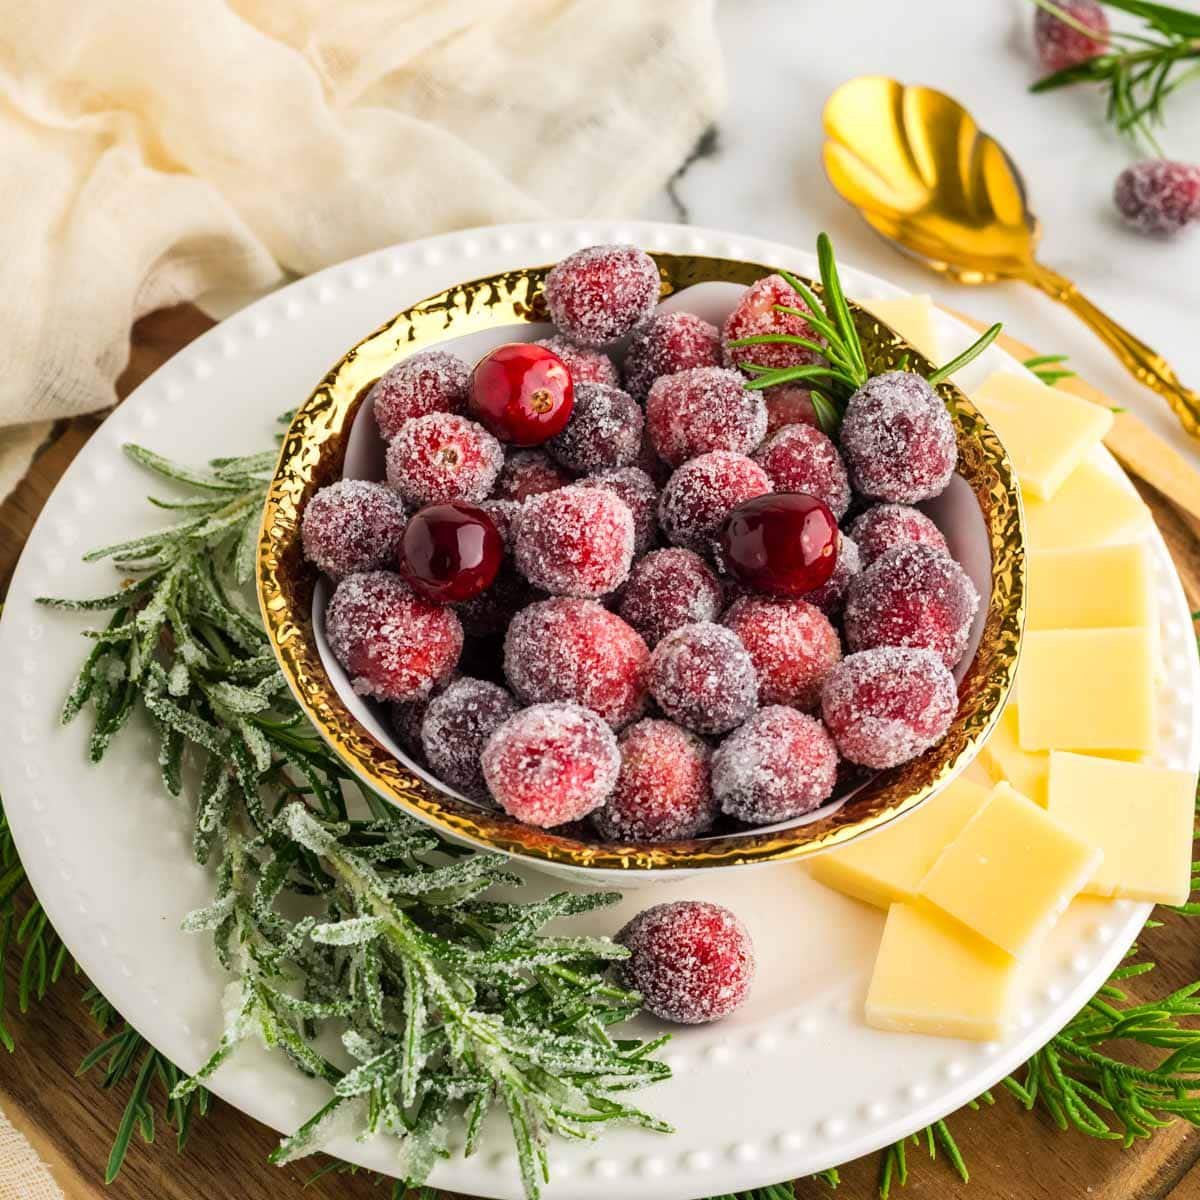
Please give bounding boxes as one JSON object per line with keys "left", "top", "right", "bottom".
{"left": 0, "top": 222, "right": 1200, "bottom": 1200}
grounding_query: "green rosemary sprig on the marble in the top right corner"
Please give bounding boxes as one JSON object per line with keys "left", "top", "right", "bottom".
{"left": 1031, "top": 0, "right": 1200, "bottom": 155}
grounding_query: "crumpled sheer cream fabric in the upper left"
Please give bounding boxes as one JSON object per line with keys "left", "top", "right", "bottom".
{"left": 0, "top": 0, "right": 722, "bottom": 494}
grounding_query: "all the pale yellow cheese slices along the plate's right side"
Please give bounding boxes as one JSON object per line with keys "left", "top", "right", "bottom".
{"left": 810, "top": 298, "right": 1196, "bottom": 1039}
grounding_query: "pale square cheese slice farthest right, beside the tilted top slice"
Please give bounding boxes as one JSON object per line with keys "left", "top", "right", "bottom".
{"left": 1049, "top": 751, "right": 1196, "bottom": 904}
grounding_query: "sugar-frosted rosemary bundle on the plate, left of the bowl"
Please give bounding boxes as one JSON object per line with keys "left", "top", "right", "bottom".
{"left": 41, "top": 429, "right": 670, "bottom": 1196}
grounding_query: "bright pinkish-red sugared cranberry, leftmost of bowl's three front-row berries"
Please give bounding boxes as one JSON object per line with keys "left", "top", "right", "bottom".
{"left": 481, "top": 704, "right": 620, "bottom": 829}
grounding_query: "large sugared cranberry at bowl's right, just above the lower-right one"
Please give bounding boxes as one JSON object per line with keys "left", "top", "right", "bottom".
{"left": 845, "top": 542, "right": 979, "bottom": 667}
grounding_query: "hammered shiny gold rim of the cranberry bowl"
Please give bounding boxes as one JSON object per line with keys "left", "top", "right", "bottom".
{"left": 257, "top": 251, "right": 1026, "bottom": 871}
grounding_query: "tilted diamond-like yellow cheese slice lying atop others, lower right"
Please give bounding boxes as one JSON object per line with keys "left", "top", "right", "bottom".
{"left": 920, "top": 784, "right": 1104, "bottom": 959}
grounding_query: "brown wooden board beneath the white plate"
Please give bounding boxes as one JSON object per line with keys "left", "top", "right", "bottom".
{"left": 0, "top": 307, "right": 1200, "bottom": 1200}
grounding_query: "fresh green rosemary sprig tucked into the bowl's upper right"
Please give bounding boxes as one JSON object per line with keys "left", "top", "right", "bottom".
{"left": 728, "top": 233, "right": 1001, "bottom": 437}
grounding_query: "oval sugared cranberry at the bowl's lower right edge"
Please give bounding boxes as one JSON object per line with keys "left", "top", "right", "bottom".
{"left": 821, "top": 646, "right": 959, "bottom": 770}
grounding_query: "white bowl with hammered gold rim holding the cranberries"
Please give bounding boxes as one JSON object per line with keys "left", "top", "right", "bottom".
{"left": 258, "top": 253, "right": 1025, "bottom": 886}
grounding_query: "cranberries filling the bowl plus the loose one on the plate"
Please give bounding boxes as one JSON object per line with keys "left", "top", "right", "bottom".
{"left": 301, "top": 246, "right": 979, "bottom": 844}
